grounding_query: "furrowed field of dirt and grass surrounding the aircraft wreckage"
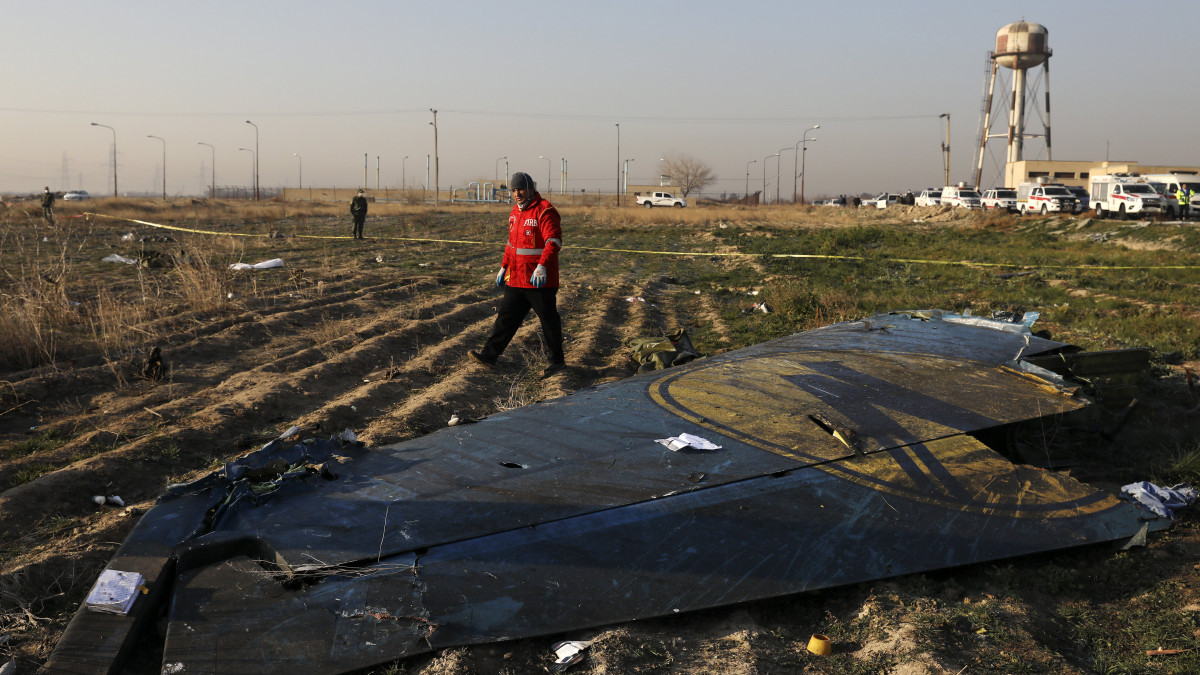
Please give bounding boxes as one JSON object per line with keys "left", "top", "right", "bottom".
{"left": 0, "top": 199, "right": 1200, "bottom": 675}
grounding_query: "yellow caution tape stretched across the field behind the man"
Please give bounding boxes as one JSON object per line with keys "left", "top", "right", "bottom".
{"left": 83, "top": 211, "right": 1200, "bottom": 270}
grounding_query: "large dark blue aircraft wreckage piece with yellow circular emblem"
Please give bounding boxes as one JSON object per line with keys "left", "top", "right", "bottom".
{"left": 46, "top": 311, "right": 1168, "bottom": 673}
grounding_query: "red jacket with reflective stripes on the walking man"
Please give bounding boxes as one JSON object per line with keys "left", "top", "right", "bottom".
{"left": 502, "top": 193, "right": 563, "bottom": 288}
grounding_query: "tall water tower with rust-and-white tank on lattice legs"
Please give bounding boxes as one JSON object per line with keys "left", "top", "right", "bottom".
{"left": 976, "top": 20, "right": 1054, "bottom": 185}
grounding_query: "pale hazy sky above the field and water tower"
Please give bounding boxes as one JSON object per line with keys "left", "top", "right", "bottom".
{"left": 0, "top": 0, "right": 1200, "bottom": 199}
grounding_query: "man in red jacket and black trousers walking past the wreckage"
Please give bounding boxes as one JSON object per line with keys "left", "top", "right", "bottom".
{"left": 467, "top": 172, "right": 566, "bottom": 378}
